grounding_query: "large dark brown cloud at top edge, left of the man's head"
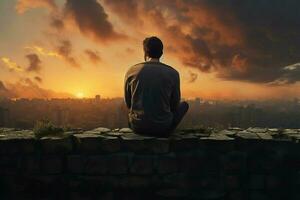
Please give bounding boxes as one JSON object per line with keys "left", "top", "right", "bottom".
{"left": 65, "top": 0, "right": 125, "bottom": 41}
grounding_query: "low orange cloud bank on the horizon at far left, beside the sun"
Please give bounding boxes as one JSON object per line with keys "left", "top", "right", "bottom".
{"left": 0, "top": 78, "right": 74, "bottom": 99}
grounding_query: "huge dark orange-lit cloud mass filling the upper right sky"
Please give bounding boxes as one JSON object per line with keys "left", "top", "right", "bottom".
{"left": 104, "top": 0, "right": 300, "bottom": 84}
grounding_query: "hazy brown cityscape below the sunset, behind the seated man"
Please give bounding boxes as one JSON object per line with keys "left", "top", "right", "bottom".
{"left": 0, "top": 95, "right": 300, "bottom": 130}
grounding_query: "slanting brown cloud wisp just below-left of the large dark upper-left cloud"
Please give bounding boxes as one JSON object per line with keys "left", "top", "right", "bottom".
{"left": 56, "top": 40, "right": 80, "bottom": 67}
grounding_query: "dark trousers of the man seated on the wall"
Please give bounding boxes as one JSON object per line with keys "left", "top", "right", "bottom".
{"left": 128, "top": 102, "right": 189, "bottom": 137}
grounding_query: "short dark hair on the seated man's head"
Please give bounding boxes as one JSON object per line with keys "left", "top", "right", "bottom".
{"left": 143, "top": 36, "right": 164, "bottom": 59}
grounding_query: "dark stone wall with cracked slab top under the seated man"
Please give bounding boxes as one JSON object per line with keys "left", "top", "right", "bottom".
{"left": 0, "top": 128, "right": 300, "bottom": 200}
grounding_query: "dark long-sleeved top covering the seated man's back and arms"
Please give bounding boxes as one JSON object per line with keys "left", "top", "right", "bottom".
{"left": 125, "top": 62, "right": 180, "bottom": 132}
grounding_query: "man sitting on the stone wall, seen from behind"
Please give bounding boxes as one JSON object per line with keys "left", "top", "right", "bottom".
{"left": 125, "top": 37, "right": 189, "bottom": 137}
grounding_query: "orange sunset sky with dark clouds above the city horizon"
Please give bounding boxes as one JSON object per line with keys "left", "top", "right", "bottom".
{"left": 0, "top": 0, "right": 300, "bottom": 100}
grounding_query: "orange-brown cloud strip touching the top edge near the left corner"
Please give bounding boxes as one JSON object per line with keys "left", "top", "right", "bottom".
{"left": 16, "top": 0, "right": 57, "bottom": 14}
